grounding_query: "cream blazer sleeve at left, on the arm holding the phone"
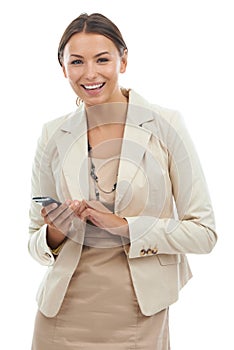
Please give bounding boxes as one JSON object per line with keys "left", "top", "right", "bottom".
{"left": 28, "top": 125, "right": 57, "bottom": 266}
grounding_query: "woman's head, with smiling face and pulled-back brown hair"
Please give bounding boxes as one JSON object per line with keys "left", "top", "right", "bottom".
{"left": 58, "top": 14, "right": 127, "bottom": 105}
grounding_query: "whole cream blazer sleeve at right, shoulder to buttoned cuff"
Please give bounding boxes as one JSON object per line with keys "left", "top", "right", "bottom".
{"left": 126, "top": 113, "right": 217, "bottom": 258}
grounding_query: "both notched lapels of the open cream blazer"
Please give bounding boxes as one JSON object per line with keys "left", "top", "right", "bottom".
{"left": 57, "top": 91, "right": 153, "bottom": 208}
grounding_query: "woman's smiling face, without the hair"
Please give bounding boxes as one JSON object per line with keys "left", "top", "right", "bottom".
{"left": 63, "top": 33, "right": 127, "bottom": 106}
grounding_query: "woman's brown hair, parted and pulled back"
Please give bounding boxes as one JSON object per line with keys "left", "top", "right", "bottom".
{"left": 58, "top": 13, "right": 127, "bottom": 65}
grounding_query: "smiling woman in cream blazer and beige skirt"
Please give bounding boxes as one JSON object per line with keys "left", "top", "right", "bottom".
{"left": 29, "top": 14, "right": 217, "bottom": 350}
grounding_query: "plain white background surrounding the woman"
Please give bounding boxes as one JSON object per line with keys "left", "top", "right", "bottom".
{"left": 0, "top": 0, "right": 234, "bottom": 350}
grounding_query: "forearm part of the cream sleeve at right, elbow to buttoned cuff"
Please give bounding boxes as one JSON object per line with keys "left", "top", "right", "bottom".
{"left": 127, "top": 216, "right": 217, "bottom": 258}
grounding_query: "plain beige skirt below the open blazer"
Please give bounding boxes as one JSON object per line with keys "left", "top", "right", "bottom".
{"left": 32, "top": 246, "right": 170, "bottom": 350}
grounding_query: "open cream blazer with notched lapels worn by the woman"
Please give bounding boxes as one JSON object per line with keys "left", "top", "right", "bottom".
{"left": 29, "top": 90, "right": 217, "bottom": 317}
